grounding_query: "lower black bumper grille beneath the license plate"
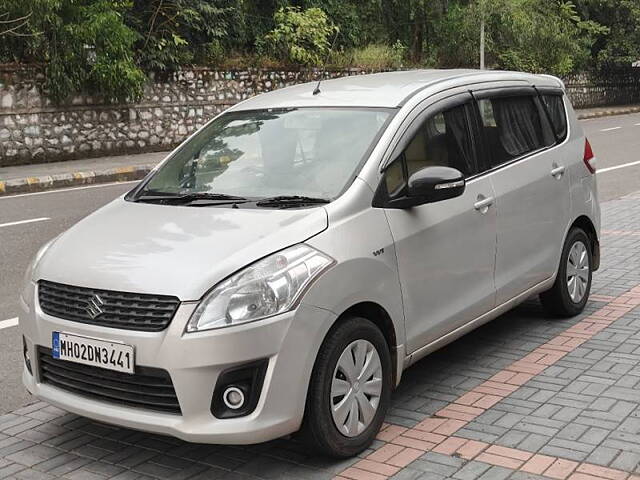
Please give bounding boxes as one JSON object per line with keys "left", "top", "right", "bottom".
{"left": 38, "top": 347, "right": 182, "bottom": 415}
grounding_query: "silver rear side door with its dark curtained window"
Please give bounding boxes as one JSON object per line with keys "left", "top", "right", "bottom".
{"left": 474, "top": 87, "right": 571, "bottom": 305}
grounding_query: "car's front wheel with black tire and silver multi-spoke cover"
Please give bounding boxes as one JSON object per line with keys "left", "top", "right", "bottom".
{"left": 300, "top": 317, "right": 392, "bottom": 458}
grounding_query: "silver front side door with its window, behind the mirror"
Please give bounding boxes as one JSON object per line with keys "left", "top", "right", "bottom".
{"left": 384, "top": 99, "right": 496, "bottom": 353}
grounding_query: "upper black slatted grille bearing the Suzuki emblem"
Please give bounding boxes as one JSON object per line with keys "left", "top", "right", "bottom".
{"left": 38, "top": 280, "right": 180, "bottom": 332}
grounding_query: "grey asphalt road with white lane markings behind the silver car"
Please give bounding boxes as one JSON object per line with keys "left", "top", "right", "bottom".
{"left": 0, "top": 114, "right": 640, "bottom": 414}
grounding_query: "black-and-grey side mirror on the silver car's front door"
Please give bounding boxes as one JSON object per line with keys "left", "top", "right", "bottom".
{"left": 407, "top": 167, "right": 466, "bottom": 205}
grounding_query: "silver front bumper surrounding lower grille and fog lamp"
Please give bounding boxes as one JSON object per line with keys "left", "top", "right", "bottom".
{"left": 20, "top": 284, "right": 335, "bottom": 444}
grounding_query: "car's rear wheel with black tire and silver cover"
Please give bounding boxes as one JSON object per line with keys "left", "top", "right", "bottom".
{"left": 540, "top": 228, "right": 593, "bottom": 317}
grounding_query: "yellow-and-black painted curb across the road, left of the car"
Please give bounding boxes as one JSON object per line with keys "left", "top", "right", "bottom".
{"left": 0, "top": 164, "right": 155, "bottom": 197}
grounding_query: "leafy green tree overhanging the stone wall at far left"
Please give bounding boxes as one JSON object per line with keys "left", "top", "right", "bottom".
{"left": 0, "top": 0, "right": 145, "bottom": 102}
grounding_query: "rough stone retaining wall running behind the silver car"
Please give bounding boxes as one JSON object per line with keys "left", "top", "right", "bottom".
{"left": 0, "top": 67, "right": 640, "bottom": 167}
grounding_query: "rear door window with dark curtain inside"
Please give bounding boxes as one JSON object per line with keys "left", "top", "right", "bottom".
{"left": 478, "top": 95, "right": 553, "bottom": 166}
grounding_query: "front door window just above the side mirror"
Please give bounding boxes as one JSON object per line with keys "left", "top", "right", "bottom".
{"left": 384, "top": 105, "right": 477, "bottom": 196}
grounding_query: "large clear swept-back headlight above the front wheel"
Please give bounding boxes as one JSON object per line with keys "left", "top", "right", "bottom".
{"left": 187, "top": 244, "right": 333, "bottom": 332}
